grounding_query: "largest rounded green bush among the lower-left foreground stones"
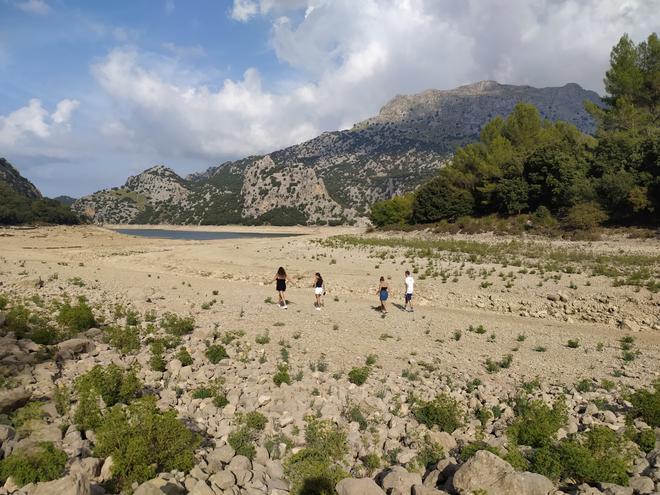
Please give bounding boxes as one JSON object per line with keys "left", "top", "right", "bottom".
{"left": 94, "top": 396, "right": 199, "bottom": 489}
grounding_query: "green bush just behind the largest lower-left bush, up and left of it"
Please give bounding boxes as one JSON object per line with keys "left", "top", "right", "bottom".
{"left": 73, "top": 364, "right": 142, "bottom": 430}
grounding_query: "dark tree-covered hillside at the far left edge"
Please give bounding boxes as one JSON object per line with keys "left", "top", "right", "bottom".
{"left": 0, "top": 158, "right": 79, "bottom": 225}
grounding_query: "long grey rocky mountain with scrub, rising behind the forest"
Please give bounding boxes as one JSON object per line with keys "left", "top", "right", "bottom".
{"left": 73, "top": 81, "right": 600, "bottom": 225}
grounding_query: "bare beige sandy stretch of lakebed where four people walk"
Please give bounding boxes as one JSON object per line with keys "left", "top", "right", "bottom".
{"left": 0, "top": 226, "right": 660, "bottom": 392}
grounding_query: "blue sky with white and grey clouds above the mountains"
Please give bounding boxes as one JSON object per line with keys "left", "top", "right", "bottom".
{"left": 0, "top": 0, "right": 660, "bottom": 197}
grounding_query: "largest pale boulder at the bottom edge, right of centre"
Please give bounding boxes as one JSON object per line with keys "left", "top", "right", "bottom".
{"left": 453, "top": 450, "right": 555, "bottom": 495}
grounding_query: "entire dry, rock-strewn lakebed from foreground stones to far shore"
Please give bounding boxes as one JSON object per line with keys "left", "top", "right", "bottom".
{"left": 0, "top": 227, "right": 660, "bottom": 495}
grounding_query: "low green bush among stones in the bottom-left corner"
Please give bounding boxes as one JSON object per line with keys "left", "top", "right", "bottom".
{"left": 0, "top": 442, "right": 67, "bottom": 487}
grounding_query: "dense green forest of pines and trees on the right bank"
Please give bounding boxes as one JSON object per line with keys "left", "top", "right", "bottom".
{"left": 371, "top": 33, "right": 660, "bottom": 230}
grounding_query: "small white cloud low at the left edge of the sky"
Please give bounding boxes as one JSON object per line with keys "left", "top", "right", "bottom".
{"left": 0, "top": 98, "right": 78, "bottom": 150}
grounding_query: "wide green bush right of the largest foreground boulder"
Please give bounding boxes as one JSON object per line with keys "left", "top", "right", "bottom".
{"left": 531, "top": 426, "right": 631, "bottom": 485}
